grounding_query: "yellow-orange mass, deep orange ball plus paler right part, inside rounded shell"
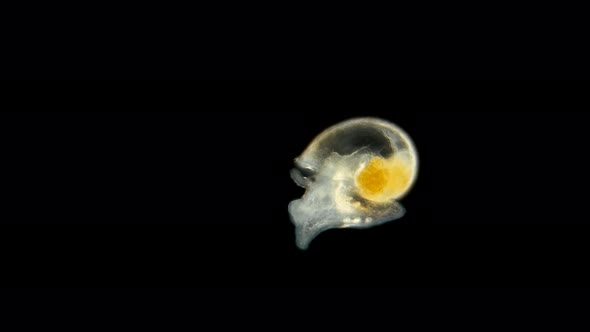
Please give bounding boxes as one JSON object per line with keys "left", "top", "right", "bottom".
{"left": 356, "top": 157, "right": 412, "bottom": 202}
